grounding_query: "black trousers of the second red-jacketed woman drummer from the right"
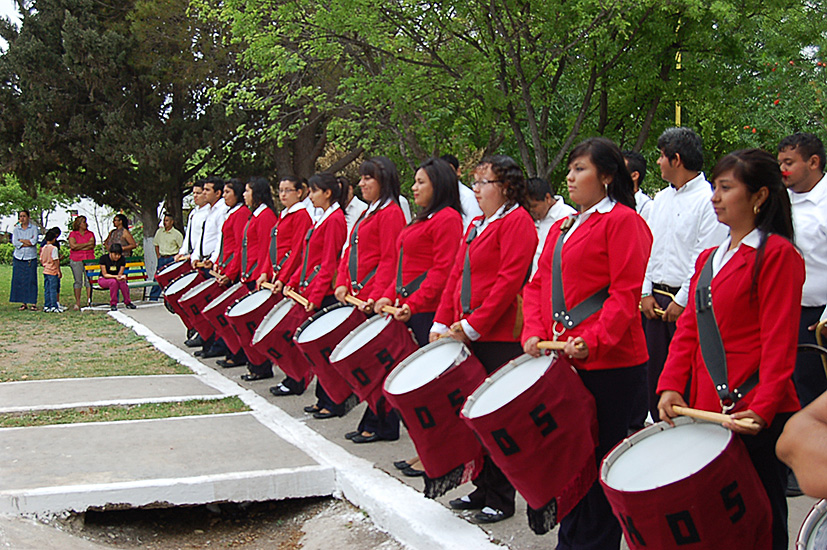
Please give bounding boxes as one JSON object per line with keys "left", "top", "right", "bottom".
{"left": 557, "top": 364, "right": 646, "bottom": 550}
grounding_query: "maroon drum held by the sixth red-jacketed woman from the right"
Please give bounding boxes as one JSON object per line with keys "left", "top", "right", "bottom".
{"left": 250, "top": 298, "right": 311, "bottom": 384}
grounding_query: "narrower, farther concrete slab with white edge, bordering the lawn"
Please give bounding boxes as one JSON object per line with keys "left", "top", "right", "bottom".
{"left": 0, "top": 374, "right": 226, "bottom": 413}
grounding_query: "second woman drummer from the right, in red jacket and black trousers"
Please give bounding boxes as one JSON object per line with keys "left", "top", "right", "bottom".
{"left": 522, "top": 138, "right": 652, "bottom": 549}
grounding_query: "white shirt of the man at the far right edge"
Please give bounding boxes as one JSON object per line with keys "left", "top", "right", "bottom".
{"left": 787, "top": 176, "right": 827, "bottom": 307}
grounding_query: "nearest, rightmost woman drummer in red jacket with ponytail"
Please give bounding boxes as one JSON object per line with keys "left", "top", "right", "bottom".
{"left": 658, "top": 149, "right": 804, "bottom": 550}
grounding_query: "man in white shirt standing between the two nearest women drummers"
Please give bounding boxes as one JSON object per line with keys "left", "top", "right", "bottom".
{"left": 640, "top": 128, "right": 727, "bottom": 419}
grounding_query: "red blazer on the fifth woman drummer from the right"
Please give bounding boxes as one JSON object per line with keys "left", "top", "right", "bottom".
{"left": 336, "top": 201, "right": 405, "bottom": 300}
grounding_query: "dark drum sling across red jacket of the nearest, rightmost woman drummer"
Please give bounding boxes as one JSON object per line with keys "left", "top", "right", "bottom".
{"left": 695, "top": 252, "right": 758, "bottom": 412}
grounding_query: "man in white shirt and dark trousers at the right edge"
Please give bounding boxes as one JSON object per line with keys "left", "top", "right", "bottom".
{"left": 778, "top": 133, "right": 827, "bottom": 407}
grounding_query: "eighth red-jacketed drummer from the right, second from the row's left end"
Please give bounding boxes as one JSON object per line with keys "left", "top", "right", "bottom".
{"left": 240, "top": 178, "right": 276, "bottom": 381}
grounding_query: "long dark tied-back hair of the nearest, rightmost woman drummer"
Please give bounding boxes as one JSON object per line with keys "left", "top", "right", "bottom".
{"left": 712, "top": 149, "right": 795, "bottom": 290}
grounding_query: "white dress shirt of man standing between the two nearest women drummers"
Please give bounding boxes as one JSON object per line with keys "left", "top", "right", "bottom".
{"left": 643, "top": 173, "right": 728, "bottom": 307}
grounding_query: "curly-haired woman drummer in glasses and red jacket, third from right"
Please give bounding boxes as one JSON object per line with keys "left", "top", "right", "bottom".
{"left": 430, "top": 155, "right": 537, "bottom": 523}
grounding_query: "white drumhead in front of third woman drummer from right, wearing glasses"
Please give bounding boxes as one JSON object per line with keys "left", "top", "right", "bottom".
{"left": 385, "top": 339, "right": 467, "bottom": 395}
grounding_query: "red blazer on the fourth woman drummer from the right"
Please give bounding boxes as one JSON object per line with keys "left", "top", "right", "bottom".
{"left": 382, "top": 208, "right": 462, "bottom": 313}
